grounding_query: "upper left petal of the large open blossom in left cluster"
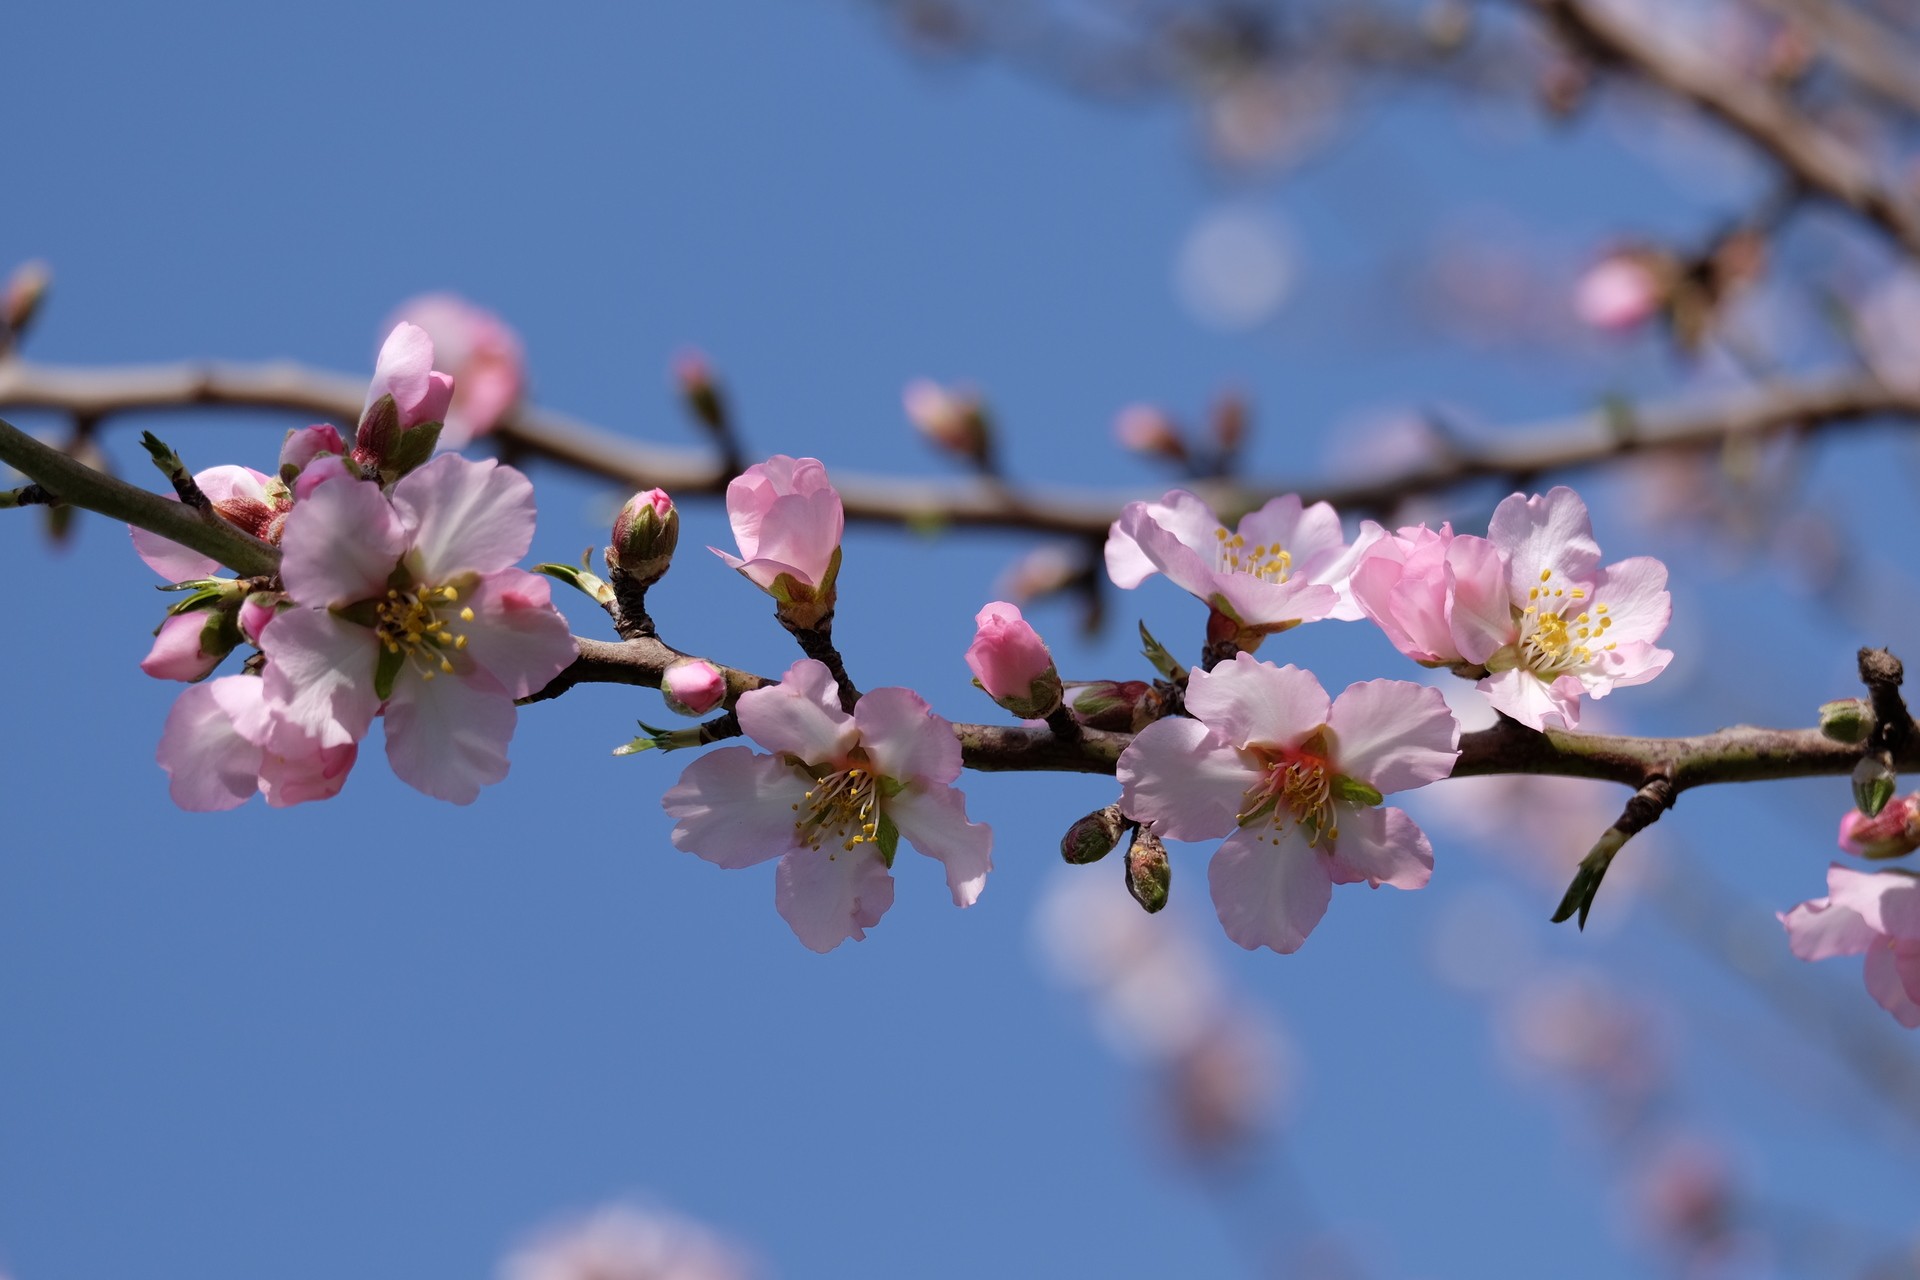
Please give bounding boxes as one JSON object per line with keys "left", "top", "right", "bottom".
{"left": 280, "top": 478, "right": 407, "bottom": 608}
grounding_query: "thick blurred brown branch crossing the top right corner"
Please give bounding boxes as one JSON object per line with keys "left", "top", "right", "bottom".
{"left": 1523, "top": 0, "right": 1920, "bottom": 257}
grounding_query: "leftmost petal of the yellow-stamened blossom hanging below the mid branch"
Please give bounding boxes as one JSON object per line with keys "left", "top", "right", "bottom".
{"left": 660, "top": 747, "right": 812, "bottom": 867}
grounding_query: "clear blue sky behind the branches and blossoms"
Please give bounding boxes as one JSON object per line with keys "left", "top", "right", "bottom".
{"left": 0, "top": 0, "right": 1920, "bottom": 1280}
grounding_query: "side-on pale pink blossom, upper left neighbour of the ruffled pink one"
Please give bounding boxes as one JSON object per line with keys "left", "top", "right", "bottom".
{"left": 1106, "top": 489, "right": 1384, "bottom": 637}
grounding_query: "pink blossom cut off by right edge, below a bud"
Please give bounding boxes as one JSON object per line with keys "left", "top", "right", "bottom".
{"left": 1780, "top": 862, "right": 1920, "bottom": 1029}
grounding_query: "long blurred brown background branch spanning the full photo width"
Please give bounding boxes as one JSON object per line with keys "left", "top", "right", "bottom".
{"left": 0, "top": 361, "right": 1920, "bottom": 537}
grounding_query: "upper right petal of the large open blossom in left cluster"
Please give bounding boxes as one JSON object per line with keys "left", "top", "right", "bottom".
{"left": 389, "top": 453, "right": 534, "bottom": 583}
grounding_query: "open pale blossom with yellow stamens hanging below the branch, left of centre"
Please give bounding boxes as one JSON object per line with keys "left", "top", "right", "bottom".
{"left": 662, "top": 658, "right": 993, "bottom": 952}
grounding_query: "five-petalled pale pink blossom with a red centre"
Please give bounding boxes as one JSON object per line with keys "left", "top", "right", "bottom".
{"left": 1119, "top": 652, "right": 1459, "bottom": 952}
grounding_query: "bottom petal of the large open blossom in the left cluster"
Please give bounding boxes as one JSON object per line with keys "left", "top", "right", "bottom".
{"left": 386, "top": 670, "right": 516, "bottom": 804}
